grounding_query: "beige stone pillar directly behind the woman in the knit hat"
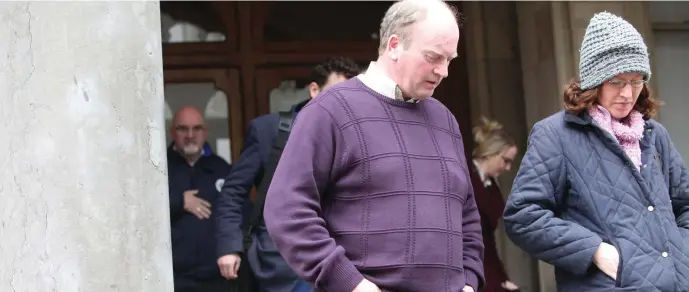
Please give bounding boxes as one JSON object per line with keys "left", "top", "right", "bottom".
{"left": 517, "top": 1, "right": 654, "bottom": 291}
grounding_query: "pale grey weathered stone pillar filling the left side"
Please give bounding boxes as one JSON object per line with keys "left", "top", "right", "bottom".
{"left": 0, "top": 1, "right": 173, "bottom": 292}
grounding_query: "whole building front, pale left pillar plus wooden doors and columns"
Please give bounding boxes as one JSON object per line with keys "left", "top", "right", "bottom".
{"left": 5, "top": 1, "right": 689, "bottom": 292}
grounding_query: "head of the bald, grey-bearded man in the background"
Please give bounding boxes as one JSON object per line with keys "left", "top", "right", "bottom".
{"left": 170, "top": 106, "right": 208, "bottom": 159}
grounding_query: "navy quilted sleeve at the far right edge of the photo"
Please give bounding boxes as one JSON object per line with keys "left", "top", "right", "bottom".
{"left": 659, "top": 126, "right": 689, "bottom": 235}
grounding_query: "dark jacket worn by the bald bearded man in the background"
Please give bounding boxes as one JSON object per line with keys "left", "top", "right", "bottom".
{"left": 167, "top": 146, "right": 231, "bottom": 285}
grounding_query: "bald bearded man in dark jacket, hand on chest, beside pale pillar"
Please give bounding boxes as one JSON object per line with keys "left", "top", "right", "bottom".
{"left": 167, "top": 106, "right": 233, "bottom": 292}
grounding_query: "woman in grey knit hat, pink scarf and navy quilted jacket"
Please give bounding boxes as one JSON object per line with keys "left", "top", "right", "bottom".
{"left": 504, "top": 12, "right": 689, "bottom": 292}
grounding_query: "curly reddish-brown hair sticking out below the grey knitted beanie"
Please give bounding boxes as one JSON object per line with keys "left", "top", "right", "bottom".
{"left": 563, "top": 79, "right": 663, "bottom": 120}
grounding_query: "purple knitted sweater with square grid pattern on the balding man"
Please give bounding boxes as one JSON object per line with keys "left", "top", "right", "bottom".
{"left": 264, "top": 78, "right": 483, "bottom": 292}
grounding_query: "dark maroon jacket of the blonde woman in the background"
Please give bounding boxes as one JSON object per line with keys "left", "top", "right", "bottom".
{"left": 469, "top": 162, "right": 509, "bottom": 292}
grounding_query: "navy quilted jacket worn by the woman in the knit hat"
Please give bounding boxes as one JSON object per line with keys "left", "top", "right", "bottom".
{"left": 504, "top": 111, "right": 689, "bottom": 292}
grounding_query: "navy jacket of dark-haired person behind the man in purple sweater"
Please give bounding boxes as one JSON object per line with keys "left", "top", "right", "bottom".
{"left": 216, "top": 100, "right": 308, "bottom": 291}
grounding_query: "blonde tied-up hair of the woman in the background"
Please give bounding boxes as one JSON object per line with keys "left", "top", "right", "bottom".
{"left": 471, "top": 117, "right": 517, "bottom": 159}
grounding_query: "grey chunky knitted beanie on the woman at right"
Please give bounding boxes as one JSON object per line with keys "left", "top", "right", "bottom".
{"left": 579, "top": 12, "right": 651, "bottom": 90}
